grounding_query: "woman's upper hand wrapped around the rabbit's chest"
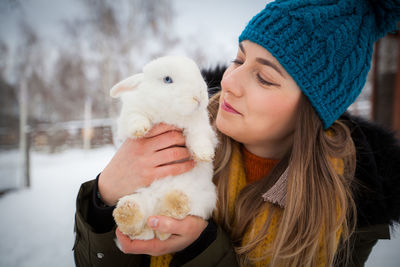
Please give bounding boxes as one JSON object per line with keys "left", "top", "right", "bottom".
{"left": 99, "top": 123, "right": 194, "bottom": 206}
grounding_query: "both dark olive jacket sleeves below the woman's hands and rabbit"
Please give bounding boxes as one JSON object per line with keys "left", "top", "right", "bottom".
{"left": 73, "top": 180, "right": 238, "bottom": 267}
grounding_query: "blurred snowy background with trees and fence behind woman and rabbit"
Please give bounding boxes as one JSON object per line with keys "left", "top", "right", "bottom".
{"left": 0, "top": 0, "right": 400, "bottom": 267}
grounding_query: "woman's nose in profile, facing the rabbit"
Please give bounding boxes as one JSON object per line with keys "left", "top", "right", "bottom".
{"left": 221, "top": 65, "right": 246, "bottom": 97}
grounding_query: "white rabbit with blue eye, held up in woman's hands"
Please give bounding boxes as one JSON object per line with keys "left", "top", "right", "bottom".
{"left": 110, "top": 56, "right": 217, "bottom": 240}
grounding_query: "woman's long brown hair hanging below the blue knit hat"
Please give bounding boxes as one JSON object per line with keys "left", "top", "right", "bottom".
{"left": 209, "top": 93, "right": 356, "bottom": 266}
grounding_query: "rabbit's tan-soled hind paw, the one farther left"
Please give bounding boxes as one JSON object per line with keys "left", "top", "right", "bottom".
{"left": 113, "top": 197, "right": 145, "bottom": 239}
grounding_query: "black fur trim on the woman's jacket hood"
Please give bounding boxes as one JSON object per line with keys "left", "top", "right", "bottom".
{"left": 202, "top": 65, "right": 400, "bottom": 227}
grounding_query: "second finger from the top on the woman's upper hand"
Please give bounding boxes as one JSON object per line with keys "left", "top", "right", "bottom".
{"left": 145, "top": 130, "right": 186, "bottom": 151}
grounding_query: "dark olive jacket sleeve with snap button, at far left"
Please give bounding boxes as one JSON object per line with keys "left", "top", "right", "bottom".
{"left": 73, "top": 180, "right": 147, "bottom": 267}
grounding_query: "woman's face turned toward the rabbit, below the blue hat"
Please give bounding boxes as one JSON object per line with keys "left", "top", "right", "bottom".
{"left": 216, "top": 41, "right": 301, "bottom": 158}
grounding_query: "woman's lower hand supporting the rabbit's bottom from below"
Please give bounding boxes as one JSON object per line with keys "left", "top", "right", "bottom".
{"left": 115, "top": 216, "right": 208, "bottom": 256}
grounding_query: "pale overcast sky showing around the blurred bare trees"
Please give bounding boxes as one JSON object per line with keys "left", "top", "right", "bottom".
{"left": 0, "top": 0, "right": 268, "bottom": 65}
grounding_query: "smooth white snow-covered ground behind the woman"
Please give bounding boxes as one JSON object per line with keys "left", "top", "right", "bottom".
{"left": 0, "top": 146, "right": 400, "bottom": 267}
